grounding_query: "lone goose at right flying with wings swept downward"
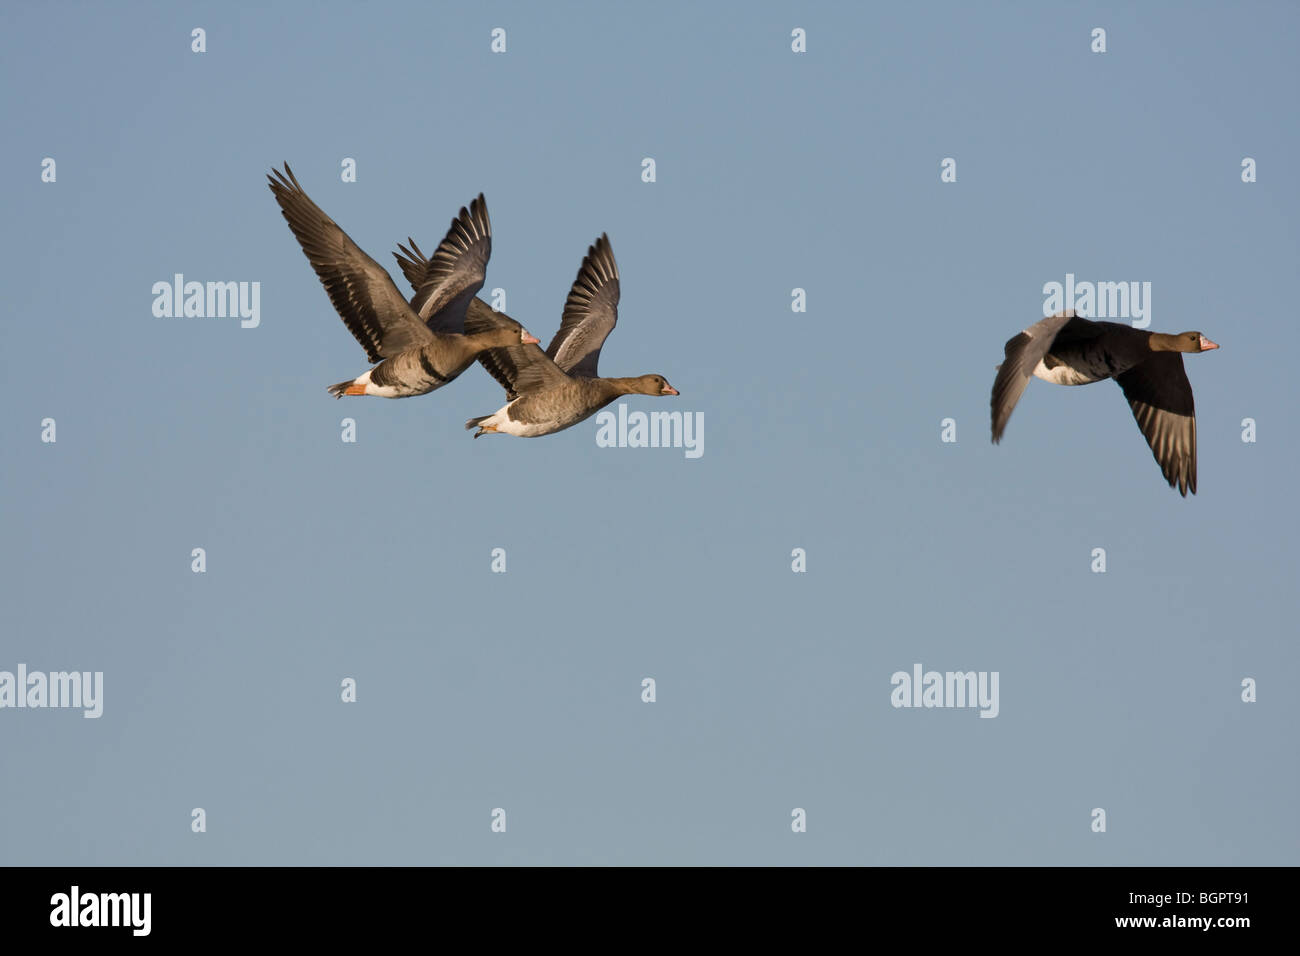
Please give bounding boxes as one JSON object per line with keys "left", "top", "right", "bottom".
{"left": 991, "top": 311, "right": 1218, "bottom": 498}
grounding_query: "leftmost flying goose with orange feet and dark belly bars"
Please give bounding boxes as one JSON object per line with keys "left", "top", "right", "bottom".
{"left": 267, "top": 163, "right": 537, "bottom": 398}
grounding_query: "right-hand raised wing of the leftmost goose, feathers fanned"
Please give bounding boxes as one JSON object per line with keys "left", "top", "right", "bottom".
{"left": 393, "top": 193, "right": 491, "bottom": 332}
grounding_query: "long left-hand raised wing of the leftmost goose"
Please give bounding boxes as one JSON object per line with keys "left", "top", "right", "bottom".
{"left": 267, "top": 163, "right": 433, "bottom": 362}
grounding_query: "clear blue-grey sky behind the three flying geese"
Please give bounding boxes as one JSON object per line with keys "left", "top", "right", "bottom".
{"left": 0, "top": 3, "right": 1300, "bottom": 865}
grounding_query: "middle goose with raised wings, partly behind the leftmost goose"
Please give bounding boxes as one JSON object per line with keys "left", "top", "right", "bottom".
{"left": 452, "top": 235, "right": 677, "bottom": 438}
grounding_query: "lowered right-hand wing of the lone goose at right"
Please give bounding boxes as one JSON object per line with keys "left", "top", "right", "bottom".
{"left": 1115, "top": 352, "right": 1196, "bottom": 498}
